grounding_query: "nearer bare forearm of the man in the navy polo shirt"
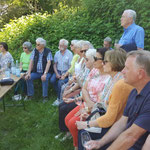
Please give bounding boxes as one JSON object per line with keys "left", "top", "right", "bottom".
{"left": 107, "top": 124, "right": 146, "bottom": 150}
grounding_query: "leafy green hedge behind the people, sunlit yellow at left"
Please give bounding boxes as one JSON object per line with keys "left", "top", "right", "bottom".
{"left": 0, "top": 0, "right": 150, "bottom": 59}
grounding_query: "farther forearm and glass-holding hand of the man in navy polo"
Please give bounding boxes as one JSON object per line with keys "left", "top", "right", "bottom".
{"left": 87, "top": 116, "right": 128, "bottom": 150}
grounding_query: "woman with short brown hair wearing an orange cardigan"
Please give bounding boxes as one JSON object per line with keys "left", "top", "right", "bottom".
{"left": 77, "top": 49, "right": 133, "bottom": 150}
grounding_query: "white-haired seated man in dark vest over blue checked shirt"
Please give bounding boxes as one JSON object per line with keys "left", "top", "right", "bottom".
{"left": 25, "top": 38, "right": 53, "bottom": 103}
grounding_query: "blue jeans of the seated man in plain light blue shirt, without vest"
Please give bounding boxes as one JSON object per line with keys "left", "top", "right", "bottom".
{"left": 50, "top": 71, "right": 68, "bottom": 99}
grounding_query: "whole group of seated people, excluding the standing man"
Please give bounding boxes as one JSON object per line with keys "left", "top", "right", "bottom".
{"left": 0, "top": 37, "right": 150, "bottom": 150}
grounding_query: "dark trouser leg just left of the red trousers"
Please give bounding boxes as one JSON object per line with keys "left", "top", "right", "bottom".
{"left": 59, "top": 102, "right": 77, "bottom": 131}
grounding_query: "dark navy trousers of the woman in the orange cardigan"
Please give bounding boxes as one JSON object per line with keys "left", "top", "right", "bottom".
{"left": 78, "top": 128, "right": 111, "bottom": 150}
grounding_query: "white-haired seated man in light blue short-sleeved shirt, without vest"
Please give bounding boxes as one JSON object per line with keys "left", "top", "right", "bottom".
{"left": 50, "top": 39, "right": 73, "bottom": 105}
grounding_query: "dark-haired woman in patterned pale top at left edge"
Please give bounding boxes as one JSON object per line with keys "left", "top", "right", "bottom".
{"left": 0, "top": 42, "right": 14, "bottom": 71}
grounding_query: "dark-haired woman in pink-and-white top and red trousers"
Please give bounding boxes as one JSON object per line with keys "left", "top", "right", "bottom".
{"left": 65, "top": 48, "right": 110, "bottom": 149}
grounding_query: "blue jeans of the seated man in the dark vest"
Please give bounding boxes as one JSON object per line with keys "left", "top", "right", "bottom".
{"left": 26, "top": 73, "right": 50, "bottom": 97}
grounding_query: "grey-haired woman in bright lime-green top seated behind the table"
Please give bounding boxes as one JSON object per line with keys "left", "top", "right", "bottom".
{"left": 12, "top": 42, "right": 32, "bottom": 100}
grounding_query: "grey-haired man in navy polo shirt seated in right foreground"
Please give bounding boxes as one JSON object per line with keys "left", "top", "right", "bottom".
{"left": 87, "top": 50, "right": 150, "bottom": 150}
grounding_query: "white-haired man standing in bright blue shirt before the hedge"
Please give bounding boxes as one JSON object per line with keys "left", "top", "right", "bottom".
{"left": 115, "top": 9, "right": 145, "bottom": 52}
